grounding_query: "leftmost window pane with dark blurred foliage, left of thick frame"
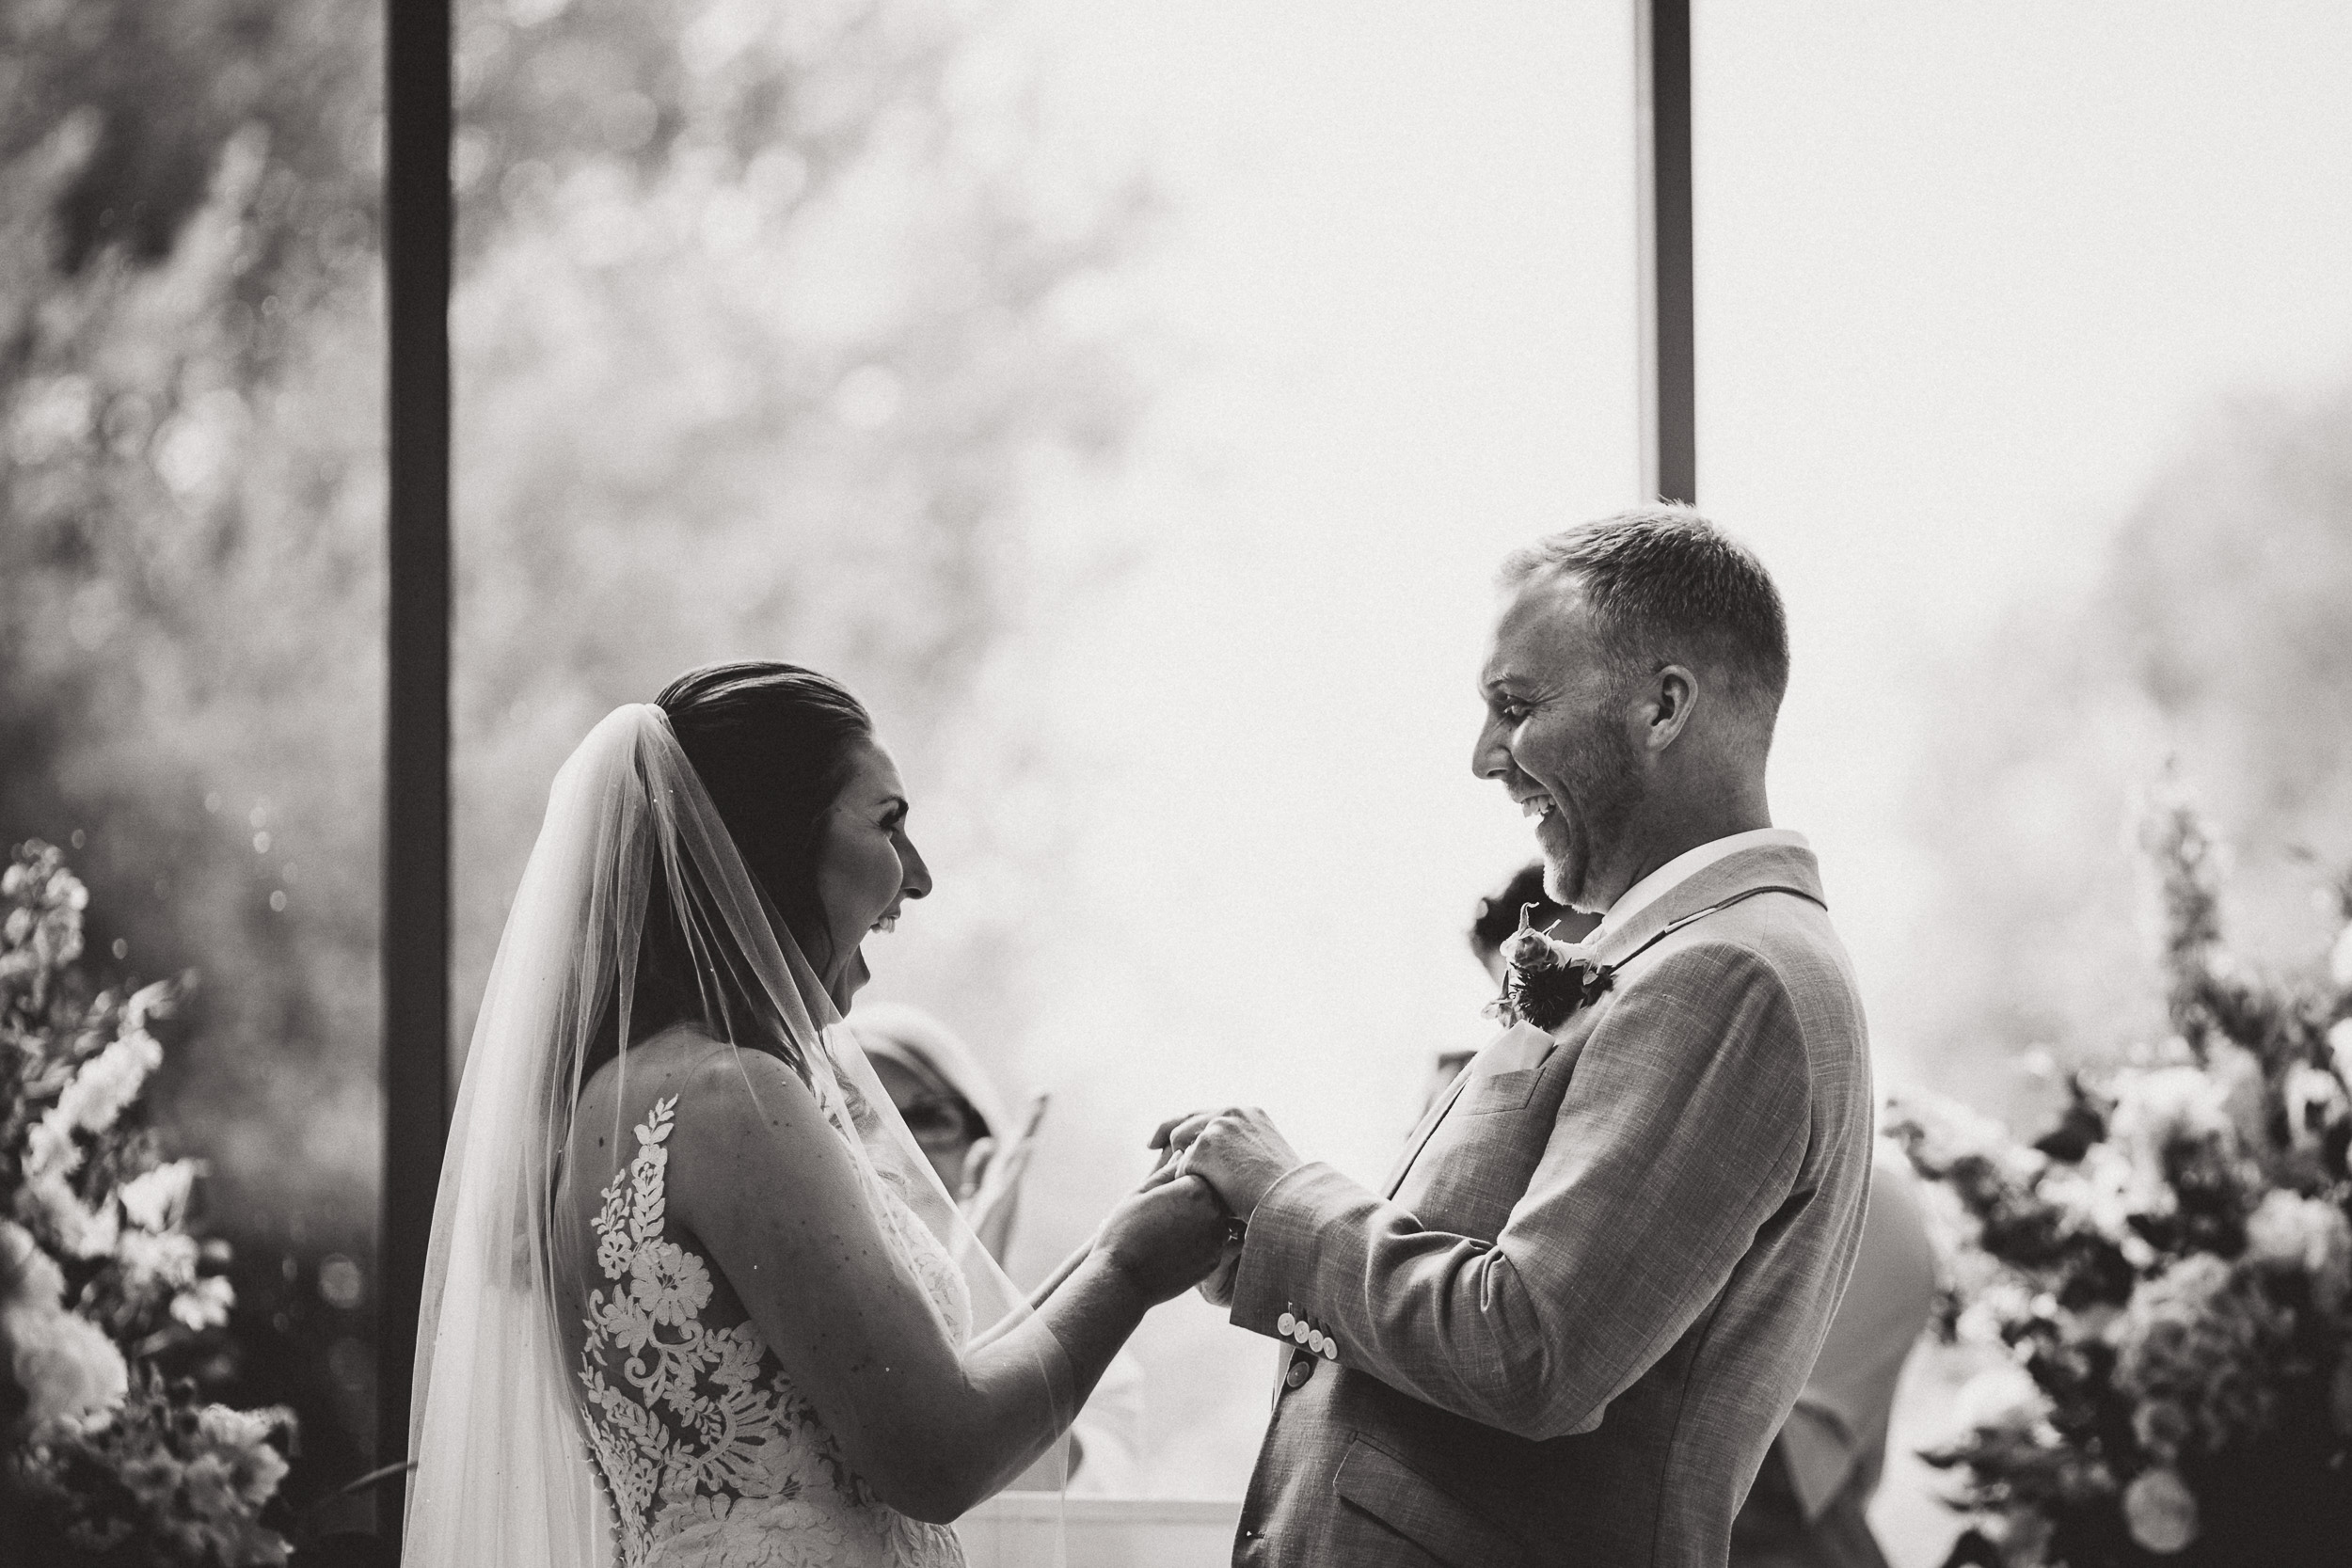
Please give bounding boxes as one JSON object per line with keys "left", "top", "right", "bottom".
{"left": 0, "top": 0, "right": 384, "bottom": 1505}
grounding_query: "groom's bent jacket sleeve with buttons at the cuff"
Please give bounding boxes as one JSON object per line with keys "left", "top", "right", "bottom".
{"left": 1232, "top": 942, "right": 1811, "bottom": 1439}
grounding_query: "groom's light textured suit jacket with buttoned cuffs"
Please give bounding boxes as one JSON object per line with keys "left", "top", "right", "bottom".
{"left": 1232, "top": 847, "right": 1870, "bottom": 1568}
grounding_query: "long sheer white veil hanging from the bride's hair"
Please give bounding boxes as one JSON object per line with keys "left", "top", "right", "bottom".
{"left": 403, "top": 703, "right": 1058, "bottom": 1568}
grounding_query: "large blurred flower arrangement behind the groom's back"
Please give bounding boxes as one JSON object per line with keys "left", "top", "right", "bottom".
{"left": 1889, "top": 795, "right": 2352, "bottom": 1568}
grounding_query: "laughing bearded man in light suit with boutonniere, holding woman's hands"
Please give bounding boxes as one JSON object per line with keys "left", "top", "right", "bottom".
{"left": 1155, "top": 508, "right": 1870, "bottom": 1568}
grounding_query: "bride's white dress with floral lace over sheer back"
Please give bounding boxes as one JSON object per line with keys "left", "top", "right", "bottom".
{"left": 579, "top": 1096, "right": 964, "bottom": 1568}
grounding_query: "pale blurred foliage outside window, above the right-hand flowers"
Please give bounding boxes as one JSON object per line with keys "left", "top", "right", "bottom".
{"left": 1903, "top": 386, "right": 2352, "bottom": 1126}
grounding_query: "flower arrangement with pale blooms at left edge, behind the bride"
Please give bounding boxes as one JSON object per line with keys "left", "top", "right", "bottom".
{"left": 0, "top": 842, "right": 292, "bottom": 1568}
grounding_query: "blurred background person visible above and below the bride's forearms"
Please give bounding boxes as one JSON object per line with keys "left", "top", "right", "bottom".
{"left": 850, "top": 1002, "right": 1143, "bottom": 1497}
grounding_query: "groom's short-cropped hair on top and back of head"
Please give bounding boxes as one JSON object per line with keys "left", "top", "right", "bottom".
{"left": 1503, "top": 505, "right": 1788, "bottom": 721}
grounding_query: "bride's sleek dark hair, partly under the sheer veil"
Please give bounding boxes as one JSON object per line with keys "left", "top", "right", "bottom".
{"left": 581, "top": 658, "right": 875, "bottom": 1084}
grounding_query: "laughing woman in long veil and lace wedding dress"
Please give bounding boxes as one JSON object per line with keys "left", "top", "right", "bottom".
{"left": 403, "top": 663, "right": 1226, "bottom": 1568}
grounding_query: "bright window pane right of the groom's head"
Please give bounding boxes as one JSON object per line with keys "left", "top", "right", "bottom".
{"left": 1696, "top": 5, "right": 2352, "bottom": 1081}
